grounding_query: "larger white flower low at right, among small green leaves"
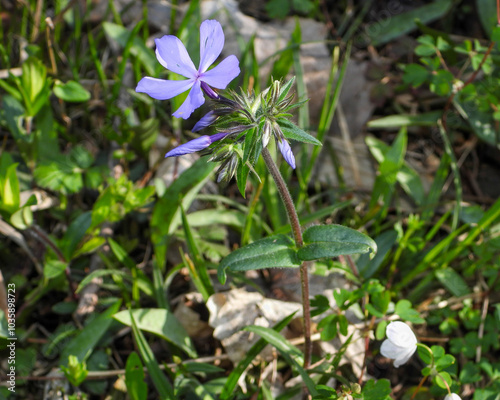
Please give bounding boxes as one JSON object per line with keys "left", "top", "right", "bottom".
{"left": 380, "top": 321, "right": 418, "bottom": 368}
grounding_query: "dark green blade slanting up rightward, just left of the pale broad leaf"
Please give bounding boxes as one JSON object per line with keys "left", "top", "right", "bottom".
{"left": 59, "top": 300, "right": 121, "bottom": 365}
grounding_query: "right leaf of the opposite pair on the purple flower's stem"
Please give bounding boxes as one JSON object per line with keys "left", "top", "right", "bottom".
{"left": 297, "top": 225, "right": 377, "bottom": 261}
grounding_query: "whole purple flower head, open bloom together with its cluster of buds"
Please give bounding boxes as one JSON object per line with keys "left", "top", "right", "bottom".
{"left": 136, "top": 20, "right": 321, "bottom": 185}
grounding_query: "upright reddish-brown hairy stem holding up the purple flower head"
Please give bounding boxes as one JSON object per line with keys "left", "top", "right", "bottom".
{"left": 262, "top": 147, "right": 312, "bottom": 368}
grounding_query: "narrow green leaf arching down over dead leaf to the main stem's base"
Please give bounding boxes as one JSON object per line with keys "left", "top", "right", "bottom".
{"left": 244, "top": 326, "right": 318, "bottom": 396}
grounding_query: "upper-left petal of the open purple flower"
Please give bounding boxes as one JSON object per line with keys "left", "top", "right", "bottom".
{"left": 155, "top": 35, "right": 198, "bottom": 78}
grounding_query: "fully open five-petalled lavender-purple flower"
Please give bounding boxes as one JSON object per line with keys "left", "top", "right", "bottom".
{"left": 135, "top": 20, "right": 240, "bottom": 119}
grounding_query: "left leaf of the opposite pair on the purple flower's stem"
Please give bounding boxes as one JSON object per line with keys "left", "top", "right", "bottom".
{"left": 217, "top": 235, "right": 300, "bottom": 283}
